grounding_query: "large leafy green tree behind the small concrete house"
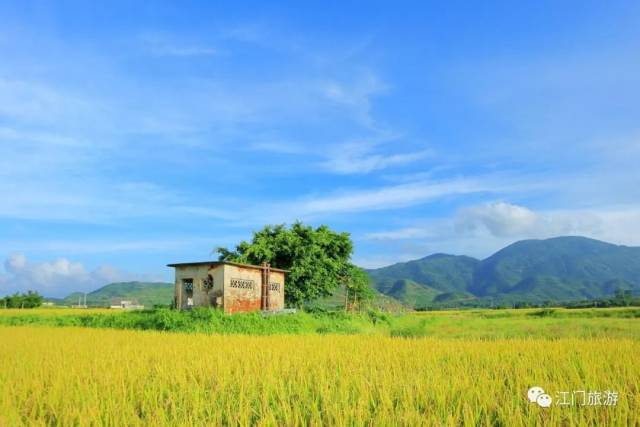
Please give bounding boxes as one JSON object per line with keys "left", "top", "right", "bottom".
{"left": 217, "top": 222, "right": 368, "bottom": 306}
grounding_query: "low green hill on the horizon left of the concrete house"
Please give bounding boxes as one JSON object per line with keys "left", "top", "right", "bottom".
{"left": 56, "top": 282, "right": 174, "bottom": 308}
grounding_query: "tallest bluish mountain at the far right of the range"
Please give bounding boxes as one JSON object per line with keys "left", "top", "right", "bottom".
{"left": 469, "top": 237, "right": 640, "bottom": 299}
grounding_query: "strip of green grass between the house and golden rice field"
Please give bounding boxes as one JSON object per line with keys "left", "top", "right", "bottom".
{"left": 0, "top": 308, "right": 640, "bottom": 340}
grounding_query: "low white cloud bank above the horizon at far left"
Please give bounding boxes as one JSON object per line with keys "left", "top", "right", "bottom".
{"left": 0, "top": 253, "right": 157, "bottom": 296}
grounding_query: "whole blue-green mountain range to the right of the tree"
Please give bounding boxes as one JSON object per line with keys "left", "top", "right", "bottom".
{"left": 368, "top": 236, "right": 640, "bottom": 307}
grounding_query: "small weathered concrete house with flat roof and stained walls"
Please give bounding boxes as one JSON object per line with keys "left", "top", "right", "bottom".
{"left": 168, "top": 261, "right": 288, "bottom": 314}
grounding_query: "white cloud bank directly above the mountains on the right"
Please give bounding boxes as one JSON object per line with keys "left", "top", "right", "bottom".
{"left": 363, "top": 201, "right": 640, "bottom": 262}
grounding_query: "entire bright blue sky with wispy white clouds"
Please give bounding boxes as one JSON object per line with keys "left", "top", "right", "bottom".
{"left": 0, "top": 1, "right": 640, "bottom": 296}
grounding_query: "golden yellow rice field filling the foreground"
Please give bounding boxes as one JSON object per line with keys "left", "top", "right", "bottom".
{"left": 0, "top": 327, "right": 640, "bottom": 426}
